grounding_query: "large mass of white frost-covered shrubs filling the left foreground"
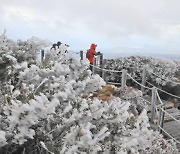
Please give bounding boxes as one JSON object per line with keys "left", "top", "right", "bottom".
{"left": 0, "top": 35, "right": 177, "bottom": 154}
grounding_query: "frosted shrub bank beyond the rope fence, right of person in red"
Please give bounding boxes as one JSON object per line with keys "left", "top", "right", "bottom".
{"left": 105, "top": 56, "right": 180, "bottom": 86}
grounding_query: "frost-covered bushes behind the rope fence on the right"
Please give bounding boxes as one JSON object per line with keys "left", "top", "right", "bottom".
{"left": 105, "top": 56, "right": 180, "bottom": 99}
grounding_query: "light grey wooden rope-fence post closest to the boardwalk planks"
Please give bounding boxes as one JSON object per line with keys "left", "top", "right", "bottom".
{"left": 151, "top": 87, "right": 156, "bottom": 124}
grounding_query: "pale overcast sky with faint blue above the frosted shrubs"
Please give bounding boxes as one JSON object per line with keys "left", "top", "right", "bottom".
{"left": 0, "top": 0, "right": 180, "bottom": 56}
